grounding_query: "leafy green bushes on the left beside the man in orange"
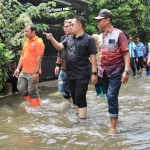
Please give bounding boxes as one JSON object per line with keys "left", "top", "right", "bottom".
{"left": 0, "top": 0, "right": 56, "bottom": 89}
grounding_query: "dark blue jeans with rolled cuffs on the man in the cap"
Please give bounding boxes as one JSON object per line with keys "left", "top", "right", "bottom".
{"left": 102, "top": 67, "right": 124, "bottom": 119}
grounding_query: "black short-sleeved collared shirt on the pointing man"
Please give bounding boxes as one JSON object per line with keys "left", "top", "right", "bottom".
{"left": 62, "top": 33, "right": 97, "bottom": 79}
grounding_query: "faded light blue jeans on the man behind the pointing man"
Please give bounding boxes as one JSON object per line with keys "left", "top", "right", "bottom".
{"left": 58, "top": 70, "right": 71, "bottom": 100}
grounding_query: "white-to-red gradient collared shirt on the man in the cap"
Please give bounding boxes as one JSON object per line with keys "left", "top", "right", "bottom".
{"left": 98, "top": 27, "right": 128, "bottom": 77}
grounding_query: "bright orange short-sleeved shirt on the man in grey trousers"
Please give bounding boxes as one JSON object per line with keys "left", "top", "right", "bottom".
{"left": 22, "top": 36, "right": 45, "bottom": 73}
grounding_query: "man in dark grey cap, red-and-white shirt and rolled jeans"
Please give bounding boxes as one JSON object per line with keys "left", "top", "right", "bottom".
{"left": 95, "top": 9, "right": 130, "bottom": 134}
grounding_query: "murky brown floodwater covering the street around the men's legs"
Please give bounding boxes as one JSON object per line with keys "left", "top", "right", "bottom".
{"left": 0, "top": 77, "right": 150, "bottom": 150}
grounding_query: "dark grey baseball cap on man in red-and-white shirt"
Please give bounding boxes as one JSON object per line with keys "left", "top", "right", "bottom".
{"left": 94, "top": 9, "right": 113, "bottom": 20}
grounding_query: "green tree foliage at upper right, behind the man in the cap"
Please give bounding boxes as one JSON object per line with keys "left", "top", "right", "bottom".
{"left": 84, "top": 0, "right": 150, "bottom": 43}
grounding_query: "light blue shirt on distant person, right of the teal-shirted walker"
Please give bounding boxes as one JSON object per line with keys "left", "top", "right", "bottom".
{"left": 135, "top": 42, "right": 145, "bottom": 58}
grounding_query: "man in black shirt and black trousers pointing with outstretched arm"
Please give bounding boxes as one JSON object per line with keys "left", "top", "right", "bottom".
{"left": 44, "top": 16, "right": 97, "bottom": 119}
